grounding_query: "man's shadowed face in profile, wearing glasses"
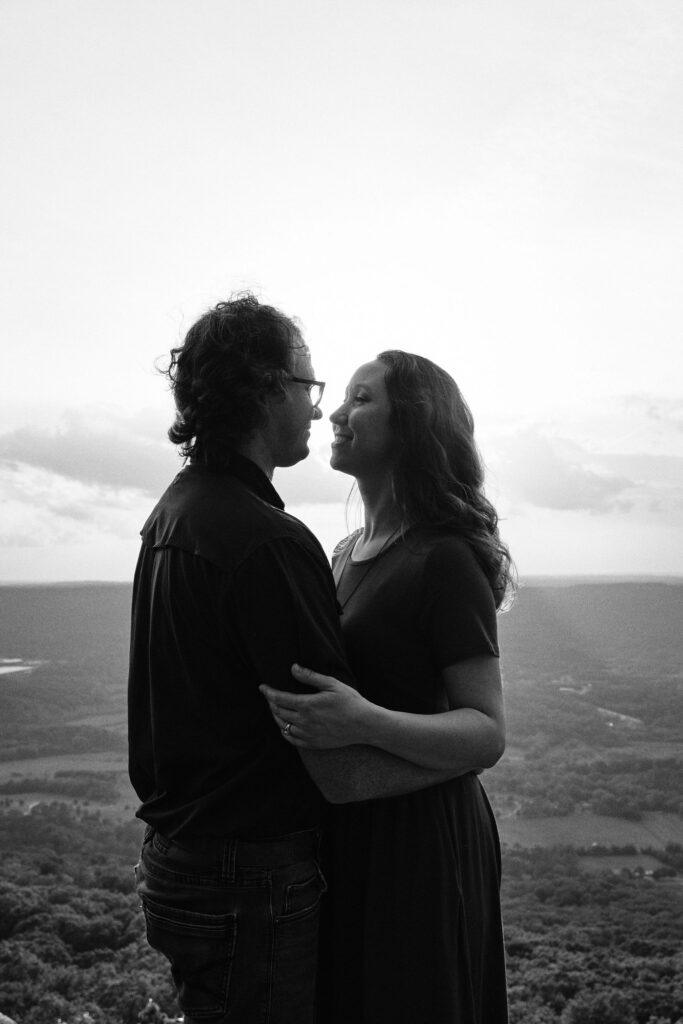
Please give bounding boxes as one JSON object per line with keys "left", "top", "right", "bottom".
{"left": 264, "top": 344, "right": 323, "bottom": 466}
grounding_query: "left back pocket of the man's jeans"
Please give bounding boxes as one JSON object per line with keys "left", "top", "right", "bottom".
{"left": 142, "top": 896, "right": 237, "bottom": 1020}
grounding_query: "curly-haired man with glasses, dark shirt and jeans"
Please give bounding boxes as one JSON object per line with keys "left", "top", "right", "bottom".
{"left": 129, "top": 295, "right": 454, "bottom": 1024}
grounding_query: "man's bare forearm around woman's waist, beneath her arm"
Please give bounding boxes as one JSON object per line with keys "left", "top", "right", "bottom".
{"left": 299, "top": 746, "right": 471, "bottom": 804}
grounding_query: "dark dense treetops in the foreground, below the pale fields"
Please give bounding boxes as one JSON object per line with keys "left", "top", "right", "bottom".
{"left": 0, "top": 803, "right": 683, "bottom": 1024}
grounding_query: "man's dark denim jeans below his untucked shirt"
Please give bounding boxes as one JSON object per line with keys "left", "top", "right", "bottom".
{"left": 135, "top": 827, "right": 327, "bottom": 1024}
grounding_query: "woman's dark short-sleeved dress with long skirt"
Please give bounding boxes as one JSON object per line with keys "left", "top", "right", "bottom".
{"left": 321, "top": 529, "right": 508, "bottom": 1024}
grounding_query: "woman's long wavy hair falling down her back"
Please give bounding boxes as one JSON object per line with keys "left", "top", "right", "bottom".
{"left": 377, "top": 349, "right": 516, "bottom": 608}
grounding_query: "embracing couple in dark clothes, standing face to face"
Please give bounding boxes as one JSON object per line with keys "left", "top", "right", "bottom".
{"left": 129, "top": 295, "right": 512, "bottom": 1024}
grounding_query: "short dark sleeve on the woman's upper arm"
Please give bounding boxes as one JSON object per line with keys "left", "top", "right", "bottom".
{"left": 413, "top": 538, "right": 499, "bottom": 669}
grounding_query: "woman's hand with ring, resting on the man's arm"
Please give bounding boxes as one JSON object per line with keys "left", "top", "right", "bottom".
{"left": 259, "top": 665, "right": 375, "bottom": 750}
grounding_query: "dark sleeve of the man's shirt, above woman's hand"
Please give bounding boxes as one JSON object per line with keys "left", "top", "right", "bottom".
{"left": 229, "top": 538, "right": 355, "bottom": 693}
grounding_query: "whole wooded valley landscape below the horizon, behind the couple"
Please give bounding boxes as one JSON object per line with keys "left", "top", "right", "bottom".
{"left": 0, "top": 582, "right": 683, "bottom": 1024}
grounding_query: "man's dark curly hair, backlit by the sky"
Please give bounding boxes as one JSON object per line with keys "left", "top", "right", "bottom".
{"left": 164, "top": 293, "right": 304, "bottom": 465}
